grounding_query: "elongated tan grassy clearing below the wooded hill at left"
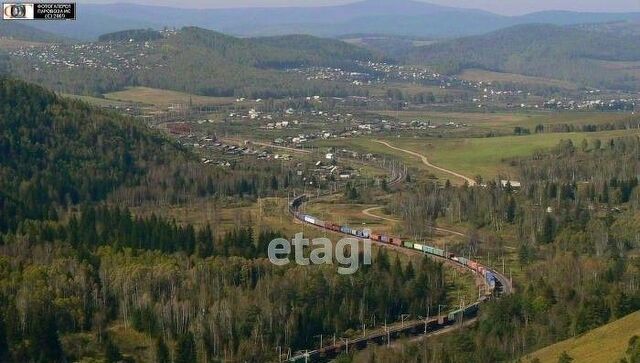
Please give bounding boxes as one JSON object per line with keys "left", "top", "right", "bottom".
{"left": 104, "top": 87, "right": 235, "bottom": 107}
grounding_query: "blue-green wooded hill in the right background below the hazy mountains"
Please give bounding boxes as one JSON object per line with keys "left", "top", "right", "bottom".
{"left": 407, "top": 24, "right": 640, "bottom": 90}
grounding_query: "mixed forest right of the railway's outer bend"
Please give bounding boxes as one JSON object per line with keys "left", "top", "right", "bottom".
{"left": 370, "top": 136, "right": 640, "bottom": 363}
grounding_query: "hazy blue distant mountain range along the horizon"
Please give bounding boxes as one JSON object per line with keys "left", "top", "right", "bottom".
{"left": 18, "top": 0, "right": 640, "bottom": 39}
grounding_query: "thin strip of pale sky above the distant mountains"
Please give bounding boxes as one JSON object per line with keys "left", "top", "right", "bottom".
{"left": 77, "top": 0, "right": 640, "bottom": 15}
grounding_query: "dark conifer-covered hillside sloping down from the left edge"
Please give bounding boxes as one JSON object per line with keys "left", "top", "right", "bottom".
{"left": 0, "top": 79, "right": 188, "bottom": 234}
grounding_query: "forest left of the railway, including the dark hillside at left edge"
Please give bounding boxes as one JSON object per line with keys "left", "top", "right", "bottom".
{"left": 0, "top": 79, "right": 447, "bottom": 362}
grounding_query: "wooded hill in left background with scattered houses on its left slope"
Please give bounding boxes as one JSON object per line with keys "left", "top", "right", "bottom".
{"left": 11, "top": 27, "right": 380, "bottom": 98}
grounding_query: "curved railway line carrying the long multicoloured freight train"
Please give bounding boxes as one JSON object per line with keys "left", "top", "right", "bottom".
{"left": 284, "top": 193, "right": 513, "bottom": 362}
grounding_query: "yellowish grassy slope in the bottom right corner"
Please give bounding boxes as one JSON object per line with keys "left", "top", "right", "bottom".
{"left": 524, "top": 311, "right": 640, "bottom": 363}
